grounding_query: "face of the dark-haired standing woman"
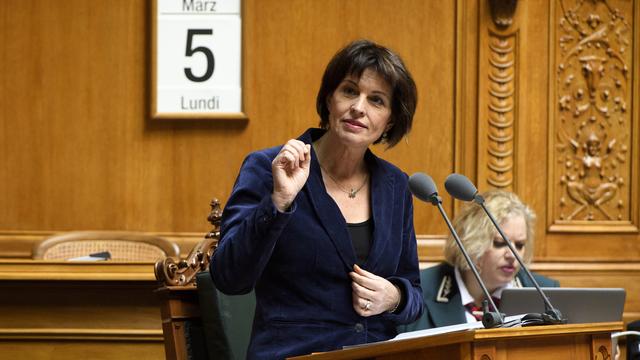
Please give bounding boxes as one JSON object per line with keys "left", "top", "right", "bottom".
{"left": 327, "top": 69, "right": 393, "bottom": 147}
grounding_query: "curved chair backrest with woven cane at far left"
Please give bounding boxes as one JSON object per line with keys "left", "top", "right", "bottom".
{"left": 33, "top": 231, "right": 180, "bottom": 262}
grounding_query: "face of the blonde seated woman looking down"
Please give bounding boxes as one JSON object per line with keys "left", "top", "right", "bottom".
{"left": 478, "top": 215, "right": 527, "bottom": 292}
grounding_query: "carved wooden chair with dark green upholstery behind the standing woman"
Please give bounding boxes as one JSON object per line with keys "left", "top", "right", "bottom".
{"left": 155, "top": 199, "right": 255, "bottom": 360}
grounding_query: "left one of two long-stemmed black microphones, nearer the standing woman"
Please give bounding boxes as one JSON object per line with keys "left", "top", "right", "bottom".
{"left": 409, "top": 173, "right": 504, "bottom": 329}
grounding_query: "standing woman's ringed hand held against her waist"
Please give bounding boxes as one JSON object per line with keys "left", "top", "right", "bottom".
{"left": 349, "top": 265, "right": 401, "bottom": 317}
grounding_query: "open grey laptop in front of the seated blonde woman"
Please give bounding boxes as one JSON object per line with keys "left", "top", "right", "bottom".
{"left": 499, "top": 287, "right": 626, "bottom": 324}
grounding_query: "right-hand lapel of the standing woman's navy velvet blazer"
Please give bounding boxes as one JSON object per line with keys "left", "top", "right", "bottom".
{"left": 365, "top": 150, "right": 392, "bottom": 272}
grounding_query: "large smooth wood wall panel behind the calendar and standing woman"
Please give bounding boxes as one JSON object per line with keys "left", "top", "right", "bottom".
{"left": 0, "top": 0, "right": 456, "bottom": 257}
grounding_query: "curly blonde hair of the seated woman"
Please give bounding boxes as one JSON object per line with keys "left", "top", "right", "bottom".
{"left": 444, "top": 190, "right": 536, "bottom": 270}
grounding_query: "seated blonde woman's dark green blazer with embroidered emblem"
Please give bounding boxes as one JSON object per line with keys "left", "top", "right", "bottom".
{"left": 398, "top": 263, "right": 560, "bottom": 332}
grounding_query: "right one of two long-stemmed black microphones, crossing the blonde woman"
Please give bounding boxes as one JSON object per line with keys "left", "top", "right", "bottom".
{"left": 444, "top": 173, "right": 567, "bottom": 325}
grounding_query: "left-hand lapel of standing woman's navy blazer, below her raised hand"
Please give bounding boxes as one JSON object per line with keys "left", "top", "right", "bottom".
{"left": 305, "top": 141, "right": 356, "bottom": 271}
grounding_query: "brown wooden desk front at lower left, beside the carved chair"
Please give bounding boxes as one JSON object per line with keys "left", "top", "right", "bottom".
{"left": 0, "top": 260, "right": 164, "bottom": 360}
